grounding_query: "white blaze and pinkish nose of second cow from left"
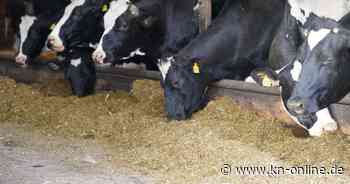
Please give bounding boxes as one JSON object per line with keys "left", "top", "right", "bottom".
{"left": 49, "top": 0, "right": 85, "bottom": 48}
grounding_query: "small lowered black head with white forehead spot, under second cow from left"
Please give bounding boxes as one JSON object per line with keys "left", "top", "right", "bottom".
{"left": 65, "top": 48, "right": 96, "bottom": 97}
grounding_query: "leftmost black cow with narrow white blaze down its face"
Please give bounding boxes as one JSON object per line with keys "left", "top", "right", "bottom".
{"left": 8, "top": 0, "right": 68, "bottom": 66}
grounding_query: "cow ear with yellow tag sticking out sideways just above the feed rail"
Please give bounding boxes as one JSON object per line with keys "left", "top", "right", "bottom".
{"left": 250, "top": 68, "right": 280, "bottom": 87}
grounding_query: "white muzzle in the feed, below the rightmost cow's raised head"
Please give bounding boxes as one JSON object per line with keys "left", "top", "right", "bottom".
{"left": 309, "top": 108, "right": 338, "bottom": 137}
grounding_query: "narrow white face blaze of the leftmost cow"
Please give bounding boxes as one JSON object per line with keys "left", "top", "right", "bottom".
{"left": 16, "top": 15, "right": 36, "bottom": 62}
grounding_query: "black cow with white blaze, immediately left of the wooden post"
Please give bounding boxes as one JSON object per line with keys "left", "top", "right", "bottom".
{"left": 93, "top": 0, "right": 198, "bottom": 69}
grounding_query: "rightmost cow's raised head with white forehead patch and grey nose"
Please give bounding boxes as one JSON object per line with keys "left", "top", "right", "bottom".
{"left": 288, "top": 23, "right": 350, "bottom": 116}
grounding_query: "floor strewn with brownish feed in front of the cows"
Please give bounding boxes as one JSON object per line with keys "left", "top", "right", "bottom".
{"left": 0, "top": 78, "right": 350, "bottom": 184}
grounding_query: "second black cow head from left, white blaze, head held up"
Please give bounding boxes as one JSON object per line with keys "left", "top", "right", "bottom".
{"left": 48, "top": 0, "right": 112, "bottom": 52}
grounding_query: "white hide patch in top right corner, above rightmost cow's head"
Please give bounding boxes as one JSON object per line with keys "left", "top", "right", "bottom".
{"left": 288, "top": 0, "right": 349, "bottom": 24}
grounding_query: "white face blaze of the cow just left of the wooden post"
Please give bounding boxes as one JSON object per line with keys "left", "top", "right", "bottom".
{"left": 92, "top": 0, "right": 130, "bottom": 63}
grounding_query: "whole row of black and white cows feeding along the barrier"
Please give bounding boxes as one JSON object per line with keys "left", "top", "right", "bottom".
{"left": 8, "top": 0, "right": 350, "bottom": 136}
